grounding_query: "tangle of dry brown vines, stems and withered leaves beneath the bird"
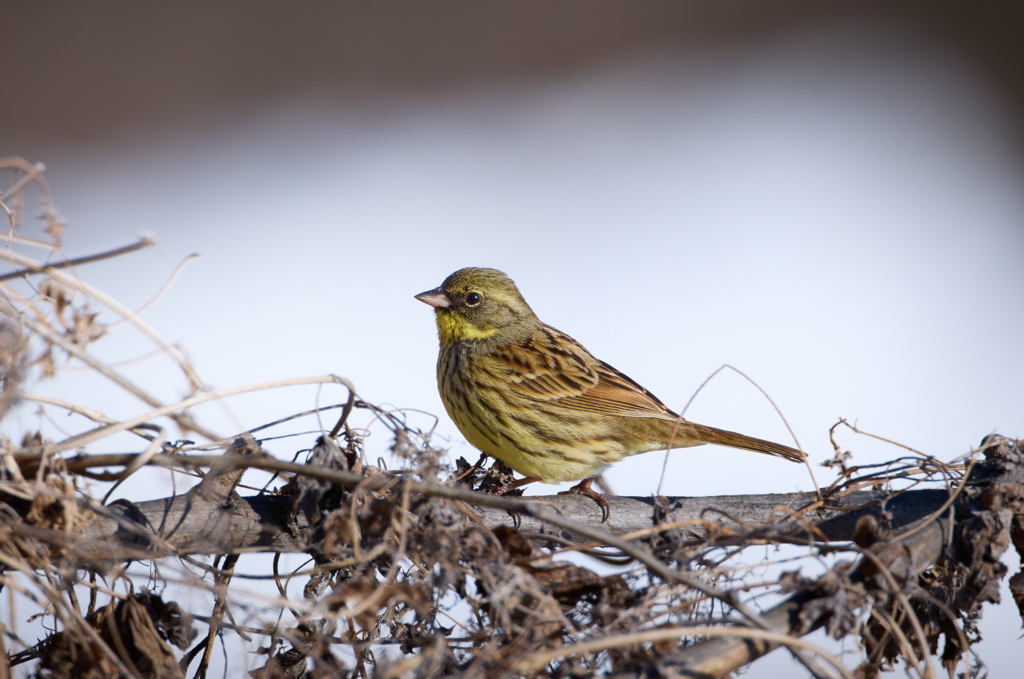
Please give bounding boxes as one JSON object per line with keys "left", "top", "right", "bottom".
{"left": 0, "top": 159, "right": 1024, "bottom": 679}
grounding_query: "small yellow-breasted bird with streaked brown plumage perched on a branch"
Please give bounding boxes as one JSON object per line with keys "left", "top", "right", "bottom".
{"left": 415, "top": 267, "right": 807, "bottom": 522}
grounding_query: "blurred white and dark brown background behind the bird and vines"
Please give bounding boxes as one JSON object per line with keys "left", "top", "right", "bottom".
{"left": 0, "top": 0, "right": 1024, "bottom": 677}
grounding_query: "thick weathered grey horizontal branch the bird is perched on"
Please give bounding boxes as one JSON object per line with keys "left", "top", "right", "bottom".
{"left": 67, "top": 455, "right": 948, "bottom": 553}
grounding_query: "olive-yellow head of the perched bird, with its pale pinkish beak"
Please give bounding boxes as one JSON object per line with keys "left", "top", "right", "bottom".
{"left": 416, "top": 267, "right": 537, "bottom": 344}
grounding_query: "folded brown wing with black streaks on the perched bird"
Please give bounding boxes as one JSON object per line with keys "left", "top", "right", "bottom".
{"left": 494, "top": 326, "right": 678, "bottom": 420}
